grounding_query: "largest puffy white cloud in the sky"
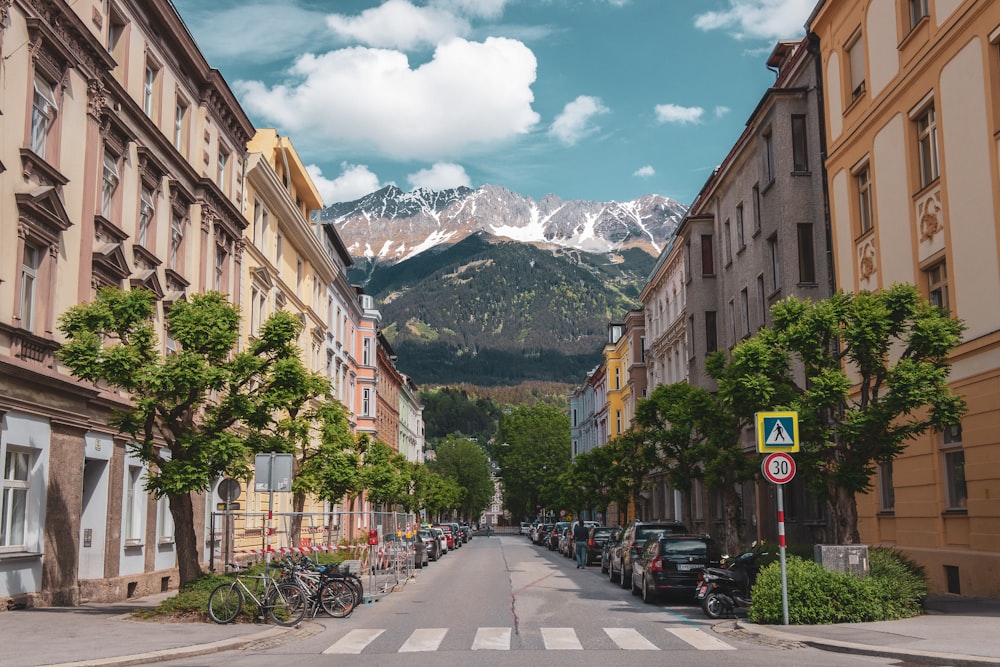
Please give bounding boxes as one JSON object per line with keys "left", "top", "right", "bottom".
{"left": 233, "top": 37, "right": 539, "bottom": 162}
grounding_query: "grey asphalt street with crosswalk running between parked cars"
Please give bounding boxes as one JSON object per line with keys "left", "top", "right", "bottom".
{"left": 161, "top": 536, "right": 898, "bottom": 667}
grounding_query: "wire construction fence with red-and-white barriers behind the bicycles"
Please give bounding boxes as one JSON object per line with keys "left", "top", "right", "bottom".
{"left": 209, "top": 511, "right": 420, "bottom": 597}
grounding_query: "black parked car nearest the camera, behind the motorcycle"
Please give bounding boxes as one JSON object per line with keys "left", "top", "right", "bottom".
{"left": 630, "top": 534, "right": 722, "bottom": 602}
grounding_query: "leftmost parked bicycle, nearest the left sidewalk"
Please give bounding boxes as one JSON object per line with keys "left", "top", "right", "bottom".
{"left": 208, "top": 564, "right": 308, "bottom": 627}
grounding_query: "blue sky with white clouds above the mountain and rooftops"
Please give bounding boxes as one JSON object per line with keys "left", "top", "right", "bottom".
{"left": 168, "top": 0, "right": 816, "bottom": 204}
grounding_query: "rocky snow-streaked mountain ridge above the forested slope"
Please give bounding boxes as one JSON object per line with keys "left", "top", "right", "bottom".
{"left": 319, "top": 185, "right": 686, "bottom": 263}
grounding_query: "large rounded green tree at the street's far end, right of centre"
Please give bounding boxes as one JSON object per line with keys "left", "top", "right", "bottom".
{"left": 495, "top": 403, "right": 570, "bottom": 517}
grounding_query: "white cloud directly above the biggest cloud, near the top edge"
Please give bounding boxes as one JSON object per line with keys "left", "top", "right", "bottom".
{"left": 326, "top": 0, "right": 470, "bottom": 50}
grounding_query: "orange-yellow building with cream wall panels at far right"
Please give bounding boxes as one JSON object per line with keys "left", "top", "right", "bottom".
{"left": 808, "top": 0, "right": 1000, "bottom": 597}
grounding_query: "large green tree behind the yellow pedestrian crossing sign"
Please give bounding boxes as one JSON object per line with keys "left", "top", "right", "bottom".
{"left": 719, "top": 284, "right": 965, "bottom": 544}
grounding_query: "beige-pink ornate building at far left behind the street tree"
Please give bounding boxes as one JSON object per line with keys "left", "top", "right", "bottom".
{"left": 0, "top": 0, "right": 253, "bottom": 605}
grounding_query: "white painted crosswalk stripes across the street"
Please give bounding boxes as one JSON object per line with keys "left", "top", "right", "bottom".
{"left": 323, "top": 626, "right": 735, "bottom": 655}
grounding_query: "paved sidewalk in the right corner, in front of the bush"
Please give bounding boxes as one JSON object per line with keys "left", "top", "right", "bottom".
{"left": 716, "top": 595, "right": 1000, "bottom": 666}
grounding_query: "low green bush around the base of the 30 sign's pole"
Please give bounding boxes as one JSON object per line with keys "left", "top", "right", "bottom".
{"left": 748, "top": 548, "right": 927, "bottom": 625}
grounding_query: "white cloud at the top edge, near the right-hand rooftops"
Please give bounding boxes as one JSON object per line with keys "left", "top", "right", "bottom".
{"left": 694, "top": 0, "right": 816, "bottom": 39}
